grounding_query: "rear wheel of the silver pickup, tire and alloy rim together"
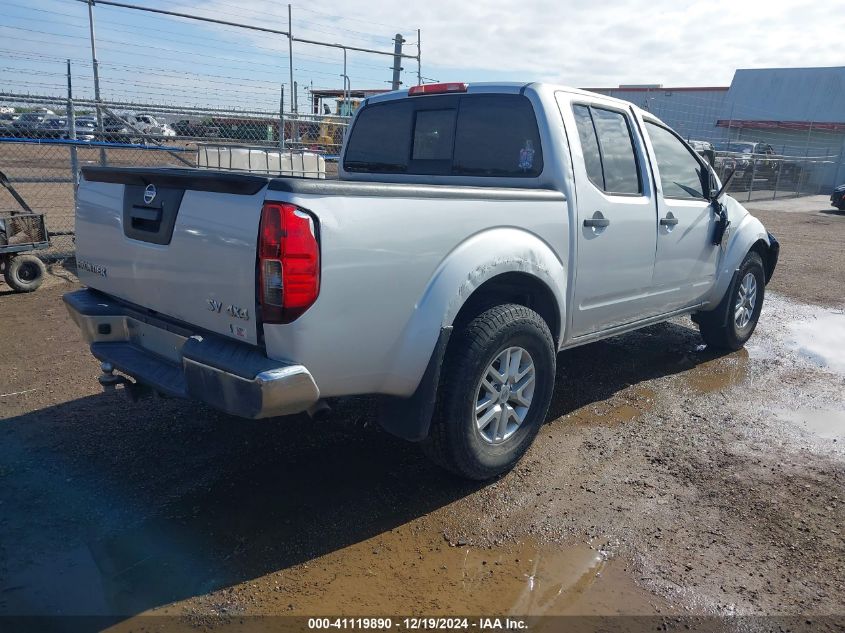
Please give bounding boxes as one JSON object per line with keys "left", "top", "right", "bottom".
{"left": 422, "top": 304, "right": 555, "bottom": 481}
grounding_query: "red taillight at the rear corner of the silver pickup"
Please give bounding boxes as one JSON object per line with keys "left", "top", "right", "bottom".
{"left": 258, "top": 202, "right": 320, "bottom": 323}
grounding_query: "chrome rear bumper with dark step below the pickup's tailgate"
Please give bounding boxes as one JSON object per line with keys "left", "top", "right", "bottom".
{"left": 63, "top": 290, "right": 320, "bottom": 418}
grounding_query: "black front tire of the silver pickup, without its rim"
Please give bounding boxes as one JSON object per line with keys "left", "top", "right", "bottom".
{"left": 696, "top": 251, "right": 766, "bottom": 350}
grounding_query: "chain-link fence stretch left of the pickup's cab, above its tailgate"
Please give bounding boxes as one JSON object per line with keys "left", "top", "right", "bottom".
{"left": 0, "top": 95, "right": 350, "bottom": 258}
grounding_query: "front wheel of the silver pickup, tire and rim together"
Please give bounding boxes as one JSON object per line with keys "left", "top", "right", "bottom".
{"left": 697, "top": 251, "right": 766, "bottom": 350}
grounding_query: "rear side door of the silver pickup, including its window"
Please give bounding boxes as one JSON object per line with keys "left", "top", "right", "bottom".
{"left": 558, "top": 93, "right": 656, "bottom": 338}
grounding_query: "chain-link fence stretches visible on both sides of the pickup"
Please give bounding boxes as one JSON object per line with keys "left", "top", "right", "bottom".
{"left": 0, "top": 94, "right": 842, "bottom": 257}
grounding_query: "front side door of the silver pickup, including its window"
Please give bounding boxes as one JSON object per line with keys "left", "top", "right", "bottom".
{"left": 644, "top": 120, "right": 719, "bottom": 312}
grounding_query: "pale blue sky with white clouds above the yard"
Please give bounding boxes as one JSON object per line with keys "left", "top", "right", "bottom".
{"left": 0, "top": 0, "right": 845, "bottom": 111}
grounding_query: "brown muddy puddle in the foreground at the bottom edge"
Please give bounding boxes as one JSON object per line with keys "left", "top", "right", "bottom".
{"left": 138, "top": 526, "right": 671, "bottom": 616}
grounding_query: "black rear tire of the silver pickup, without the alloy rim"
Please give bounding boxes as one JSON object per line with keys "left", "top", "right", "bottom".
{"left": 422, "top": 304, "right": 555, "bottom": 481}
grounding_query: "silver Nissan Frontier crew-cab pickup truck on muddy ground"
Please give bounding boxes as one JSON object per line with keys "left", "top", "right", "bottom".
{"left": 64, "top": 83, "right": 779, "bottom": 479}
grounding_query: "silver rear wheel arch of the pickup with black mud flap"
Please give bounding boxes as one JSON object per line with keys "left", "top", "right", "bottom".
{"left": 380, "top": 227, "right": 567, "bottom": 440}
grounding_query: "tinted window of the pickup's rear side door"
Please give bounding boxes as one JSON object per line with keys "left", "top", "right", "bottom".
{"left": 573, "top": 105, "right": 643, "bottom": 196}
